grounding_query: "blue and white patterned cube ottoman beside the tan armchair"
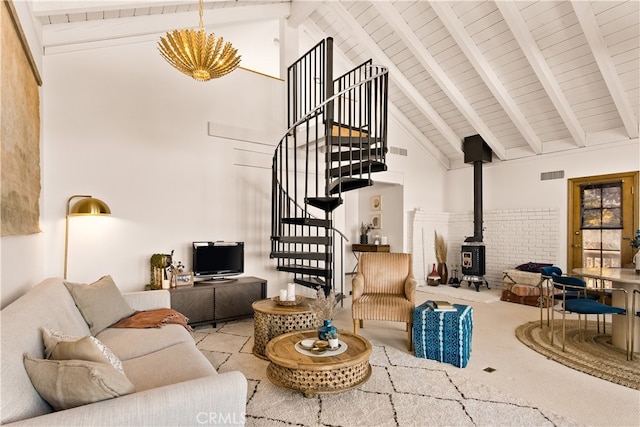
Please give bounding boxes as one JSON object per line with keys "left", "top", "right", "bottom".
{"left": 413, "top": 301, "right": 473, "bottom": 368}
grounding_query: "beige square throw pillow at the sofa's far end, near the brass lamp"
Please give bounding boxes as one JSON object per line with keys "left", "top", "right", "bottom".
{"left": 64, "top": 276, "right": 134, "bottom": 335}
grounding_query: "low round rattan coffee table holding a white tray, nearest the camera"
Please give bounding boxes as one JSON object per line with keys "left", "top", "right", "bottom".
{"left": 265, "top": 329, "right": 371, "bottom": 397}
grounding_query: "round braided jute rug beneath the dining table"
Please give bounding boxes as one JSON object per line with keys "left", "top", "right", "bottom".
{"left": 516, "top": 320, "right": 640, "bottom": 390}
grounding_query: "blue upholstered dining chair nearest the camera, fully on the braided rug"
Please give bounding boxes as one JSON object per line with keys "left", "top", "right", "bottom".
{"left": 551, "top": 276, "right": 631, "bottom": 360}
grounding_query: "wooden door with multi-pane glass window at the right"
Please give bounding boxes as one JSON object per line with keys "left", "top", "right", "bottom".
{"left": 567, "top": 171, "right": 638, "bottom": 273}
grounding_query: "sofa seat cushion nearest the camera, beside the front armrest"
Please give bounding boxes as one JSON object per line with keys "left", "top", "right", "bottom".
{"left": 123, "top": 342, "right": 217, "bottom": 391}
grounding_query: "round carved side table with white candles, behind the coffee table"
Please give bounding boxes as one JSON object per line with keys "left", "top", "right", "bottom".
{"left": 252, "top": 298, "right": 322, "bottom": 359}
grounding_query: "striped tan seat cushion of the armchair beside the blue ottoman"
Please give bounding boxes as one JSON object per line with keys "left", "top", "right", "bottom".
{"left": 351, "top": 294, "right": 414, "bottom": 322}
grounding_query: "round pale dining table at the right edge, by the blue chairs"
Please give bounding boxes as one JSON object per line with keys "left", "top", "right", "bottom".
{"left": 572, "top": 268, "right": 640, "bottom": 353}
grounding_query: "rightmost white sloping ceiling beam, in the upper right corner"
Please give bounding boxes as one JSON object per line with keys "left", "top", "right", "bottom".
{"left": 571, "top": 1, "right": 638, "bottom": 138}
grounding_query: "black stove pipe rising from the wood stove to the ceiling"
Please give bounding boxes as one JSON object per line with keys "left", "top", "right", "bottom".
{"left": 463, "top": 135, "right": 492, "bottom": 242}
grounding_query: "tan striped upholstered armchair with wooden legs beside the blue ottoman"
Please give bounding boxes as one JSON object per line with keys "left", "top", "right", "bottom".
{"left": 351, "top": 252, "right": 417, "bottom": 350}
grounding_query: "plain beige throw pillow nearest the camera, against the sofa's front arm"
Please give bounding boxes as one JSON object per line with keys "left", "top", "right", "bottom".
{"left": 24, "top": 354, "right": 135, "bottom": 411}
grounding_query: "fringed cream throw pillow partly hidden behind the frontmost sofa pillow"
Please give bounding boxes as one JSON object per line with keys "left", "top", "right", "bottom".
{"left": 42, "top": 328, "right": 124, "bottom": 374}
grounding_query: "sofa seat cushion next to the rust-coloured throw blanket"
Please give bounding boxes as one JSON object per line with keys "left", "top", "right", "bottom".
{"left": 96, "top": 324, "right": 193, "bottom": 361}
